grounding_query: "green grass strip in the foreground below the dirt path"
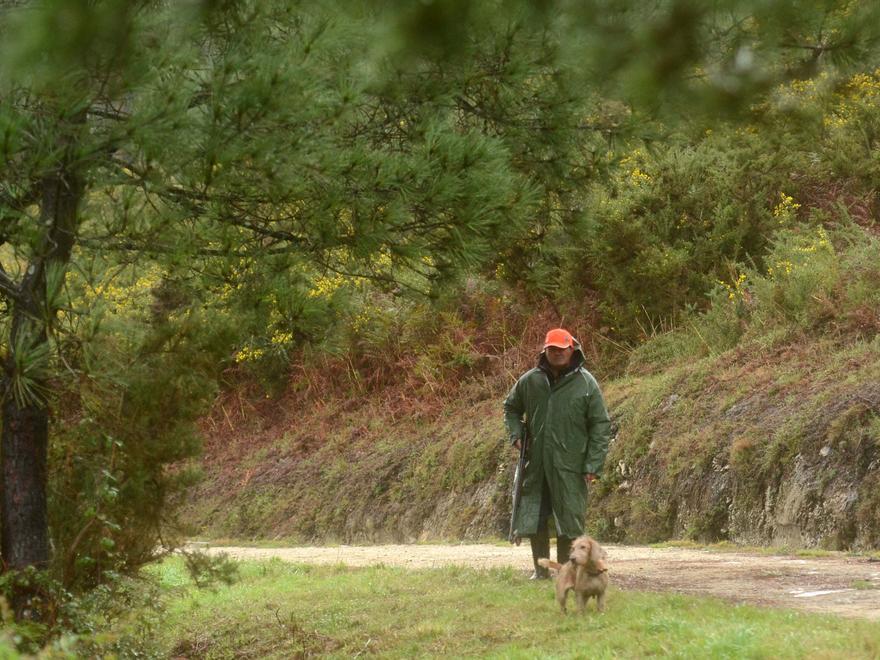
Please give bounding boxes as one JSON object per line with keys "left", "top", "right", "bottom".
{"left": 131, "top": 560, "right": 880, "bottom": 658}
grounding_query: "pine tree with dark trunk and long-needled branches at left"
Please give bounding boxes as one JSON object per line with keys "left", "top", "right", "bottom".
{"left": 0, "top": 0, "right": 531, "bottom": 600}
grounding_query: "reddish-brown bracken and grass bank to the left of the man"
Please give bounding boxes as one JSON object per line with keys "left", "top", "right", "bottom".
{"left": 186, "top": 382, "right": 511, "bottom": 543}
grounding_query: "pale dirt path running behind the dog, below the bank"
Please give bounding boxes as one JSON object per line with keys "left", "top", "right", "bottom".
{"left": 208, "top": 545, "right": 880, "bottom": 621}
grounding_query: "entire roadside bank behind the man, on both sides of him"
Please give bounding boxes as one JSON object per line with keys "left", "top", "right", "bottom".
{"left": 185, "top": 328, "right": 880, "bottom": 549}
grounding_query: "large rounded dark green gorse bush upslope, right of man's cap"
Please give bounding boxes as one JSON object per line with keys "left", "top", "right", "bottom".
{"left": 571, "top": 138, "right": 775, "bottom": 337}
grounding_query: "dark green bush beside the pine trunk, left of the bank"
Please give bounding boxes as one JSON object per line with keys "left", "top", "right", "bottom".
{"left": 49, "top": 272, "right": 235, "bottom": 592}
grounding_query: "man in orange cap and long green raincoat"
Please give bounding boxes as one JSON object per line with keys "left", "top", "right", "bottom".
{"left": 504, "top": 328, "right": 611, "bottom": 579}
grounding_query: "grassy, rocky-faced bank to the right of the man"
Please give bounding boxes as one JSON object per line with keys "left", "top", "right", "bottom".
{"left": 593, "top": 338, "right": 880, "bottom": 549}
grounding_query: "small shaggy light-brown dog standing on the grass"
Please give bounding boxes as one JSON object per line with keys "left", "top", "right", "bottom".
{"left": 538, "top": 536, "right": 608, "bottom": 614}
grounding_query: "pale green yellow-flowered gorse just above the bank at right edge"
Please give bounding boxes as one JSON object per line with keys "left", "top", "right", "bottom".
{"left": 630, "top": 224, "right": 880, "bottom": 371}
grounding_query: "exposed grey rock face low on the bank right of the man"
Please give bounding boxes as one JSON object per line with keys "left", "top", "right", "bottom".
{"left": 594, "top": 385, "right": 880, "bottom": 550}
